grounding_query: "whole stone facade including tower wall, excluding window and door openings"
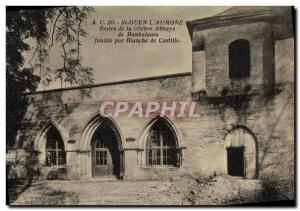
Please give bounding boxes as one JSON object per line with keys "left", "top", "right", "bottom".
{"left": 11, "top": 7, "right": 295, "bottom": 180}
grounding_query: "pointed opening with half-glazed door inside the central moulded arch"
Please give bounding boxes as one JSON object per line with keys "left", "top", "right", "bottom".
{"left": 91, "top": 123, "right": 120, "bottom": 178}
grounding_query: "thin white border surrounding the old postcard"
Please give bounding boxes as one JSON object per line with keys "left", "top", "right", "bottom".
{"left": 0, "top": 0, "right": 300, "bottom": 210}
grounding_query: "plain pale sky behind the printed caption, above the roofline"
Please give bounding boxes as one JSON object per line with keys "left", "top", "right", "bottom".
{"left": 25, "top": 6, "right": 229, "bottom": 90}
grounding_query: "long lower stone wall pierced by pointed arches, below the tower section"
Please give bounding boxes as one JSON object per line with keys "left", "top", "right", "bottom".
{"left": 12, "top": 53, "right": 294, "bottom": 180}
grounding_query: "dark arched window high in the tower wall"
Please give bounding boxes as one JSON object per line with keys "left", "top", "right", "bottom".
{"left": 228, "top": 39, "right": 250, "bottom": 79}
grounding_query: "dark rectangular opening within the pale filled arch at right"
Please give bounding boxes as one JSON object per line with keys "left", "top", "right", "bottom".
{"left": 227, "top": 147, "right": 245, "bottom": 177}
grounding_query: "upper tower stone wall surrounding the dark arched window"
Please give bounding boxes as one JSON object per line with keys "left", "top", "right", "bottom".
{"left": 193, "top": 22, "right": 274, "bottom": 96}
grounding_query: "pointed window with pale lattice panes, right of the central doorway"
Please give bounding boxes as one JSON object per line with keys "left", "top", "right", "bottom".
{"left": 146, "top": 120, "right": 177, "bottom": 166}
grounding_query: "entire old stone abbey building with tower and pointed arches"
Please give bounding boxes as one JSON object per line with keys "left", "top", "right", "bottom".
{"left": 10, "top": 7, "right": 294, "bottom": 180}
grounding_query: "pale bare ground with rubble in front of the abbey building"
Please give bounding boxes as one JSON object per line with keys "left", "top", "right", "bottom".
{"left": 8, "top": 176, "right": 268, "bottom": 205}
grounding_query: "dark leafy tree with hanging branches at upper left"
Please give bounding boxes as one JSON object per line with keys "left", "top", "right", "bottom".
{"left": 6, "top": 6, "right": 94, "bottom": 147}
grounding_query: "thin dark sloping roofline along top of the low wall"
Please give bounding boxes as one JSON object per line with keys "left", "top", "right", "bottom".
{"left": 24, "top": 72, "right": 192, "bottom": 95}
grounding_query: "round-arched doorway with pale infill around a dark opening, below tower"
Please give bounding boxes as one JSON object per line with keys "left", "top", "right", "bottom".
{"left": 225, "top": 126, "right": 258, "bottom": 179}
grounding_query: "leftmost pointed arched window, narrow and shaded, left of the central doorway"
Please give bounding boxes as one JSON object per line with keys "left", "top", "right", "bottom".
{"left": 46, "top": 127, "right": 66, "bottom": 166}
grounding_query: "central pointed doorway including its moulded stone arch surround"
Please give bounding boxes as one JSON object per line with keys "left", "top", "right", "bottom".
{"left": 78, "top": 112, "right": 124, "bottom": 179}
